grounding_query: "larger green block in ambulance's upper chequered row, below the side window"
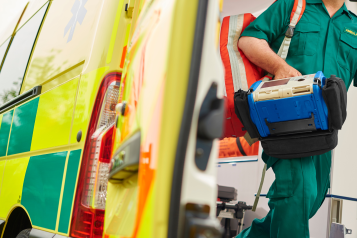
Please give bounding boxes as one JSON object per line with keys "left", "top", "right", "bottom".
{"left": 7, "top": 97, "right": 38, "bottom": 155}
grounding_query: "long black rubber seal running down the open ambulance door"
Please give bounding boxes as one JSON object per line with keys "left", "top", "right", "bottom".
{"left": 167, "top": 0, "right": 209, "bottom": 238}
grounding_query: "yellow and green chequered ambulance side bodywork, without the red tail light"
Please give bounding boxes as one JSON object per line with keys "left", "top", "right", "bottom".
{"left": 0, "top": 0, "right": 132, "bottom": 237}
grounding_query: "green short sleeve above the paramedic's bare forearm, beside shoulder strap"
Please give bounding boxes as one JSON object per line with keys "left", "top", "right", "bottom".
{"left": 241, "top": 0, "right": 294, "bottom": 44}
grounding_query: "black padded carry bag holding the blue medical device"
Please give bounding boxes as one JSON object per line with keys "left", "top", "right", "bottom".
{"left": 234, "top": 75, "right": 347, "bottom": 159}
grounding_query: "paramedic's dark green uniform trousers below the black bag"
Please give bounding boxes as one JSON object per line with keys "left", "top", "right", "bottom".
{"left": 237, "top": 152, "right": 331, "bottom": 238}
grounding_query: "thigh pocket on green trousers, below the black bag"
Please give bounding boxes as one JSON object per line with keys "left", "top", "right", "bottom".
{"left": 267, "top": 159, "right": 294, "bottom": 198}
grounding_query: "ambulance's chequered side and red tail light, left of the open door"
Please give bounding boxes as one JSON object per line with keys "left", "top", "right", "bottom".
{"left": 0, "top": 0, "right": 138, "bottom": 238}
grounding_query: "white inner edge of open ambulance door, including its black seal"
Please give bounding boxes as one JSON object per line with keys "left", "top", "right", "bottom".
{"left": 163, "top": 0, "right": 224, "bottom": 238}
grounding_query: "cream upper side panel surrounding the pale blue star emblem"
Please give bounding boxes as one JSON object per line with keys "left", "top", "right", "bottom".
{"left": 21, "top": 0, "right": 102, "bottom": 92}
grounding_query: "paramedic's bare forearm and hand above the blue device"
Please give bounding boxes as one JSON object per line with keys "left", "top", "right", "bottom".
{"left": 238, "top": 36, "right": 301, "bottom": 79}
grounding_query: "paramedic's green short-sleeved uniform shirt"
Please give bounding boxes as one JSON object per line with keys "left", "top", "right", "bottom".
{"left": 242, "top": 0, "right": 357, "bottom": 168}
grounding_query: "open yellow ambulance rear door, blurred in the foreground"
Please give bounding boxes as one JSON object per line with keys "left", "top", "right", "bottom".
{"left": 104, "top": 0, "right": 224, "bottom": 238}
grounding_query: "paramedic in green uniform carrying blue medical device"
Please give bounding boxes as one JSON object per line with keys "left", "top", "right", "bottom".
{"left": 237, "top": 0, "right": 357, "bottom": 238}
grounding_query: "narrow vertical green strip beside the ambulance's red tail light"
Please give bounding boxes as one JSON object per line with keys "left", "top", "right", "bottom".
{"left": 58, "top": 150, "right": 82, "bottom": 234}
